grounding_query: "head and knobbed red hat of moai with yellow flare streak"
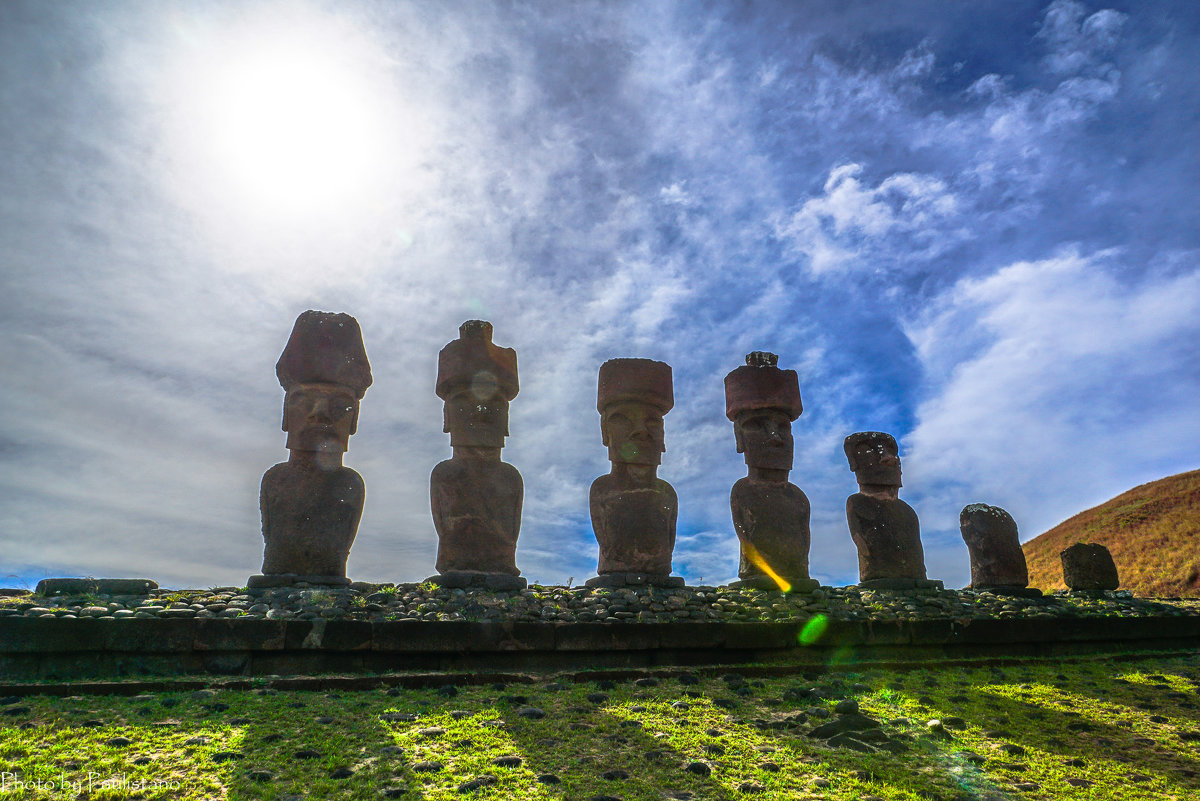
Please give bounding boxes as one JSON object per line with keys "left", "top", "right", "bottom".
{"left": 725, "top": 350, "right": 803, "bottom": 470}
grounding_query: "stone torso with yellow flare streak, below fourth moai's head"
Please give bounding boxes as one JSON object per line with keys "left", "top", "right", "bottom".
{"left": 730, "top": 477, "right": 810, "bottom": 582}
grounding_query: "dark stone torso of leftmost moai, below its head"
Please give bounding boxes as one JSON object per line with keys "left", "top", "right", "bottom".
{"left": 266, "top": 462, "right": 366, "bottom": 576}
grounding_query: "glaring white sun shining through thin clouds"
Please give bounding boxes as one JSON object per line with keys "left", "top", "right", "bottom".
{"left": 169, "top": 16, "right": 395, "bottom": 224}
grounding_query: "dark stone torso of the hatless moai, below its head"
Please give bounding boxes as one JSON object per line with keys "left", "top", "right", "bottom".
{"left": 846, "top": 493, "right": 925, "bottom": 582}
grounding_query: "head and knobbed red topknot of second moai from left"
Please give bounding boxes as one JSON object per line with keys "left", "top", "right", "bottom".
{"left": 434, "top": 320, "right": 520, "bottom": 448}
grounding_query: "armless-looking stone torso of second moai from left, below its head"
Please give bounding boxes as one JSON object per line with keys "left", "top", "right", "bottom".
{"left": 430, "top": 450, "right": 524, "bottom": 576}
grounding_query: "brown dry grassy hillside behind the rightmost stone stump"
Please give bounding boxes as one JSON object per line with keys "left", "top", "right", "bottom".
{"left": 1022, "top": 470, "right": 1200, "bottom": 597}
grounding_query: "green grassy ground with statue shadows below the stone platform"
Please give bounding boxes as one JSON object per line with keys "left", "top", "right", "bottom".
{"left": 0, "top": 656, "right": 1200, "bottom": 801}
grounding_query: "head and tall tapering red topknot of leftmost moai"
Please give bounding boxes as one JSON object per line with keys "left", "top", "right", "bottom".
{"left": 275, "top": 311, "right": 371, "bottom": 453}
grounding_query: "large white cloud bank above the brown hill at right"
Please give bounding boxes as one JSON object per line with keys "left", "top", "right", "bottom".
{"left": 904, "top": 251, "right": 1200, "bottom": 582}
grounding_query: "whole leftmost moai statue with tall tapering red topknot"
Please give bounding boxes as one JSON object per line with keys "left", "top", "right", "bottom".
{"left": 247, "top": 311, "right": 371, "bottom": 586}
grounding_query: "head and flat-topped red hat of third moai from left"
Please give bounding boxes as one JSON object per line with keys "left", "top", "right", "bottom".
{"left": 596, "top": 359, "right": 674, "bottom": 465}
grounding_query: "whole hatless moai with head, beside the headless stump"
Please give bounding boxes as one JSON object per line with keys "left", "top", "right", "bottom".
{"left": 845, "top": 432, "right": 942, "bottom": 590}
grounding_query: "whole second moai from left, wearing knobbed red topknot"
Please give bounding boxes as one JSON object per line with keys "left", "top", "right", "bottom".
{"left": 428, "top": 320, "right": 526, "bottom": 590}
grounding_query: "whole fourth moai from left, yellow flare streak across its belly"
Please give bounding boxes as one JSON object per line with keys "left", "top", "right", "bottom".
{"left": 725, "top": 351, "right": 820, "bottom": 592}
